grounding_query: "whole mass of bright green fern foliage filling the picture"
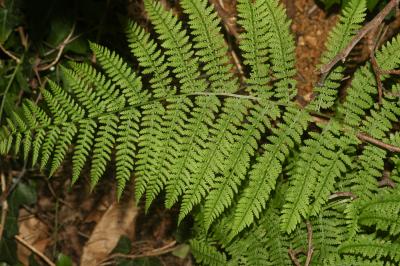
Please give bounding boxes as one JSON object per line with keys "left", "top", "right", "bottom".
{"left": 0, "top": 0, "right": 400, "bottom": 265}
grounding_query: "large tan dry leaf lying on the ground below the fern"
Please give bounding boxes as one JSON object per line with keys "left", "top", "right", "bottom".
{"left": 81, "top": 196, "right": 138, "bottom": 265}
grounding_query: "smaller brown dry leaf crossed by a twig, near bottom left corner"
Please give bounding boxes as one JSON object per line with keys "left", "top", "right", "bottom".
{"left": 17, "top": 209, "right": 51, "bottom": 265}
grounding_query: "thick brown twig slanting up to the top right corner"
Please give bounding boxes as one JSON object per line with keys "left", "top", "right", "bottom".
{"left": 319, "top": 0, "right": 400, "bottom": 86}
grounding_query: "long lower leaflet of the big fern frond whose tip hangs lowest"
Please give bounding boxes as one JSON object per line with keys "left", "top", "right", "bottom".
{"left": 232, "top": 108, "right": 309, "bottom": 235}
